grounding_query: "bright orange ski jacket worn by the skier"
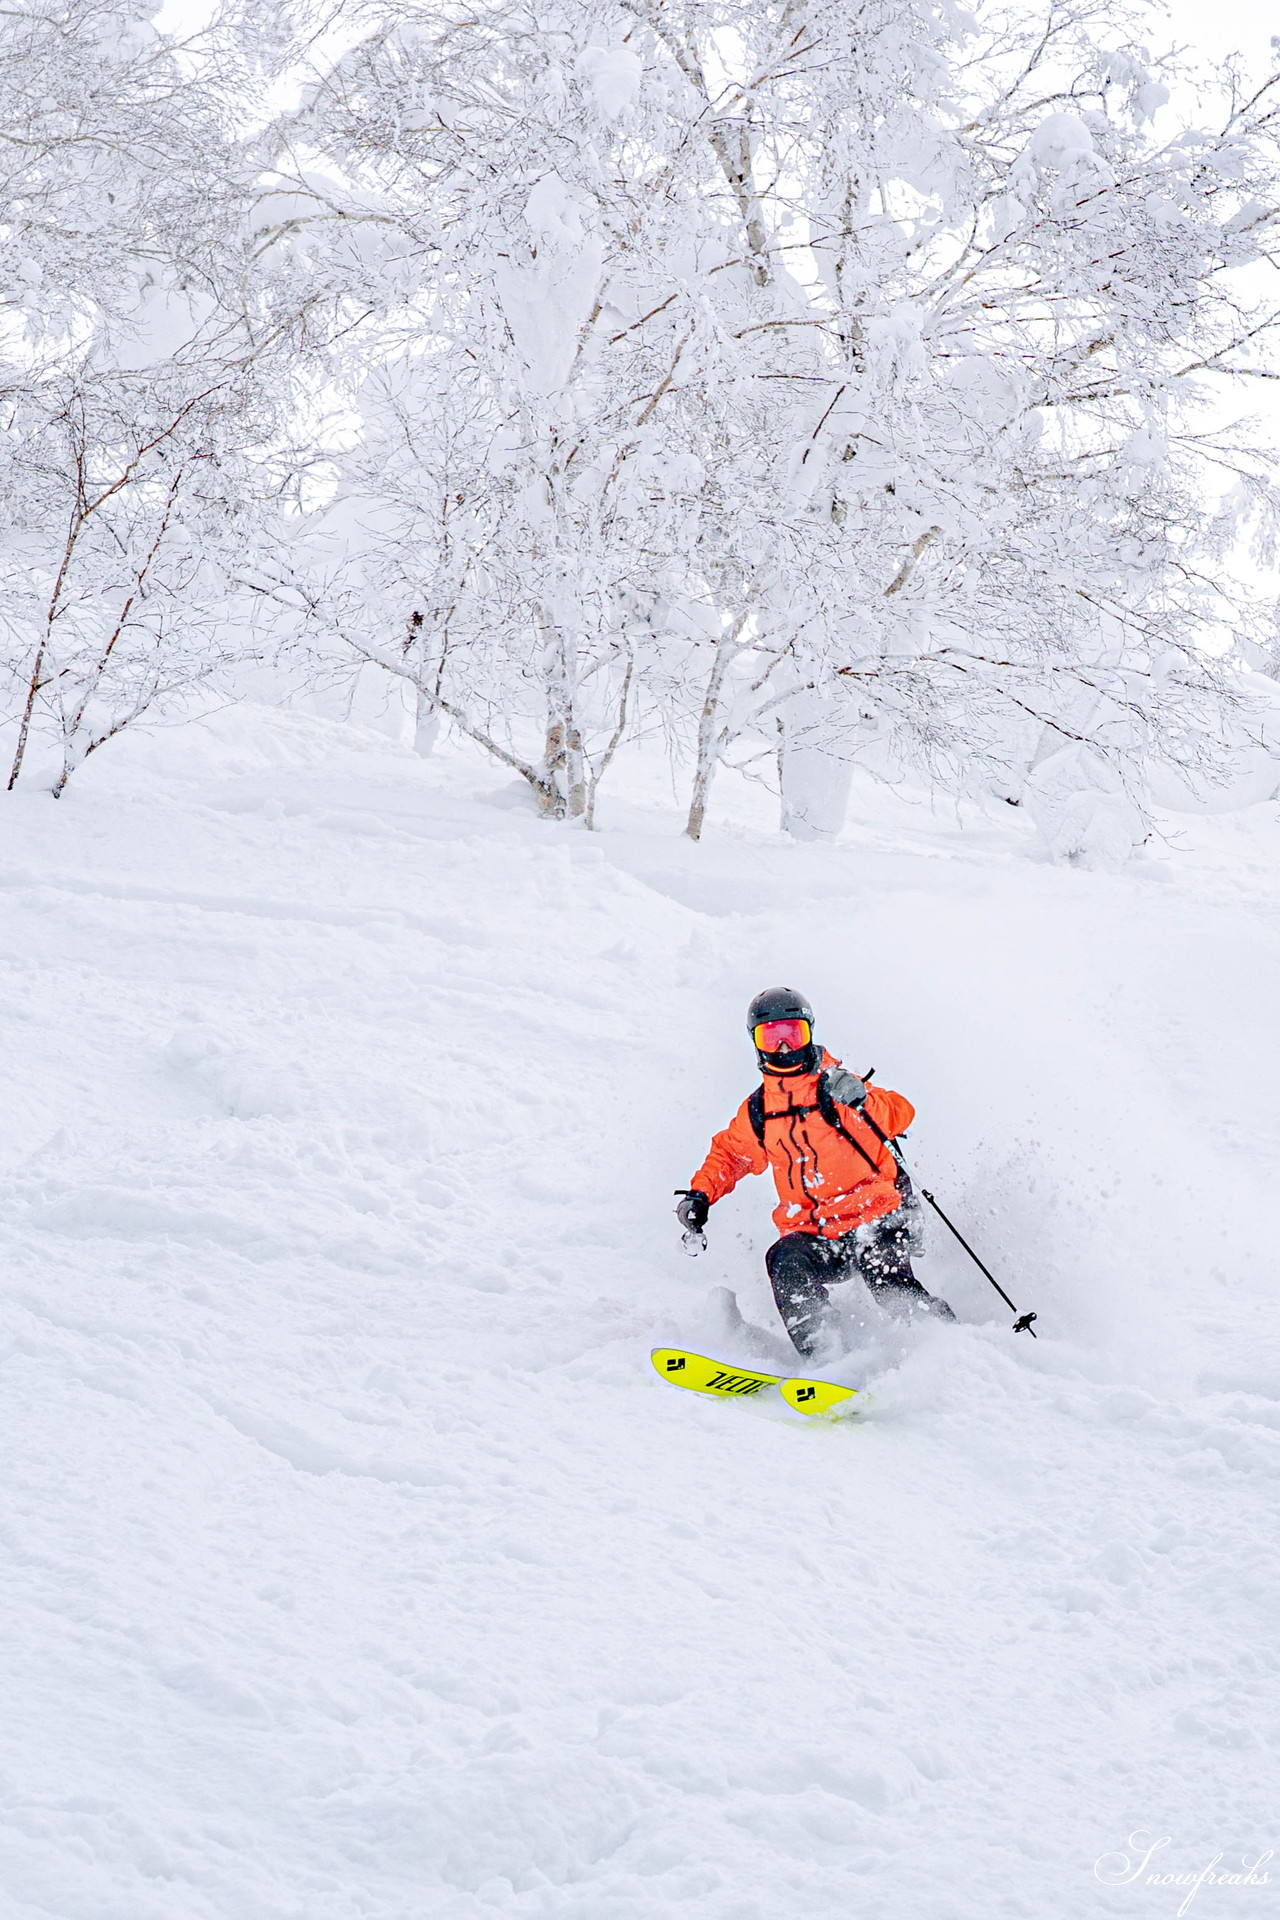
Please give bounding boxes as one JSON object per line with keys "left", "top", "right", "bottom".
{"left": 689, "top": 1050, "right": 915, "bottom": 1240}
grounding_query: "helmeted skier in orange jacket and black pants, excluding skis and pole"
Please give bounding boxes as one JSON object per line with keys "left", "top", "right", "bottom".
{"left": 676, "top": 987, "right": 956, "bottom": 1357}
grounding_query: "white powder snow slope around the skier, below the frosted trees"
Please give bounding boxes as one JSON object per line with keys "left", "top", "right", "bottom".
{"left": 0, "top": 708, "right": 1280, "bottom": 1920}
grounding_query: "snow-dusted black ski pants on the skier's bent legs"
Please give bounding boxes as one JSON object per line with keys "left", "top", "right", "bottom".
{"left": 764, "top": 1212, "right": 956, "bottom": 1359}
